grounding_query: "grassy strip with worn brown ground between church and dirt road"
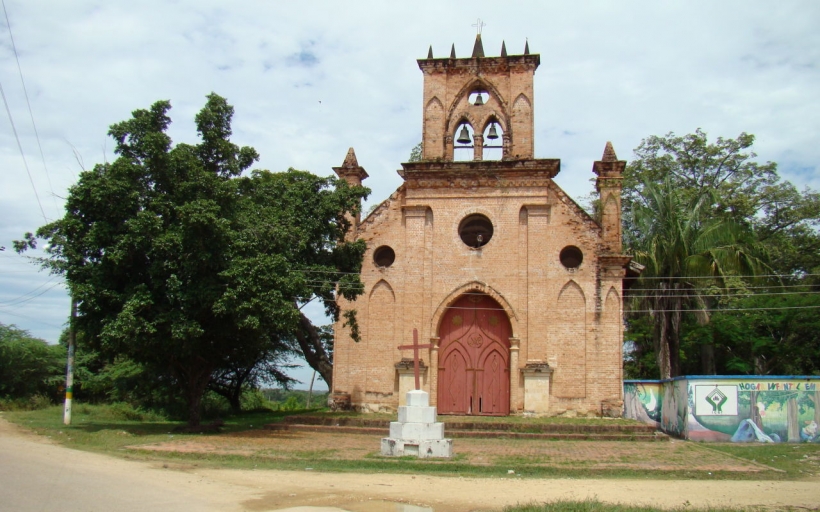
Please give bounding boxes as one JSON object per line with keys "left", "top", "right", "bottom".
{"left": 2, "top": 404, "right": 820, "bottom": 482}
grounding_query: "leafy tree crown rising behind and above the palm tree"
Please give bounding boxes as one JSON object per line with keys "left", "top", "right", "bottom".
{"left": 623, "top": 129, "right": 820, "bottom": 274}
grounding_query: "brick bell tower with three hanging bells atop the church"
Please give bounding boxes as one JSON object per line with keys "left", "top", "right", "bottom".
{"left": 418, "top": 34, "right": 541, "bottom": 162}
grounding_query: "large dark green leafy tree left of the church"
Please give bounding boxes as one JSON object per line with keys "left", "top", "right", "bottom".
{"left": 18, "top": 94, "right": 367, "bottom": 426}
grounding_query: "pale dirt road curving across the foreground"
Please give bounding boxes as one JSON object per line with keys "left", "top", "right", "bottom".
{"left": 0, "top": 416, "right": 820, "bottom": 512}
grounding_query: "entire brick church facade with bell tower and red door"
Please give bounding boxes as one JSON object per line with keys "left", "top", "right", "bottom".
{"left": 332, "top": 35, "right": 630, "bottom": 415}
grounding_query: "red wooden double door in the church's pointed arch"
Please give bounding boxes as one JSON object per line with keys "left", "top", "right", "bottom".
{"left": 437, "top": 292, "right": 512, "bottom": 416}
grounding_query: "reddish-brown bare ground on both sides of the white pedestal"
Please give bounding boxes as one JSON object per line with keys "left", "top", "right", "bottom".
{"left": 129, "top": 430, "right": 776, "bottom": 473}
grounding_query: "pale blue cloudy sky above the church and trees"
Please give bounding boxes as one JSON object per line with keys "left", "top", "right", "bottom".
{"left": 0, "top": 0, "right": 820, "bottom": 388}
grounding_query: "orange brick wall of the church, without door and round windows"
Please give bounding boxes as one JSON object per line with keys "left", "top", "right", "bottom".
{"left": 333, "top": 41, "right": 629, "bottom": 414}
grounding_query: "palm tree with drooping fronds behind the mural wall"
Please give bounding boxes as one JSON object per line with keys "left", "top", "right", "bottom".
{"left": 625, "top": 178, "right": 765, "bottom": 379}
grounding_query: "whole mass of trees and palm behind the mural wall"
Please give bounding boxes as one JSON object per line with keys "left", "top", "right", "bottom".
{"left": 623, "top": 130, "right": 820, "bottom": 377}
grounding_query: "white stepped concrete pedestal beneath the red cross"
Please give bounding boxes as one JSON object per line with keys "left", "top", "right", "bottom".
{"left": 381, "top": 389, "right": 453, "bottom": 459}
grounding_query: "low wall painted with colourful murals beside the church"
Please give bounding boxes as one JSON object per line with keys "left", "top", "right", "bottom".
{"left": 624, "top": 375, "right": 820, "bottom": 443}
